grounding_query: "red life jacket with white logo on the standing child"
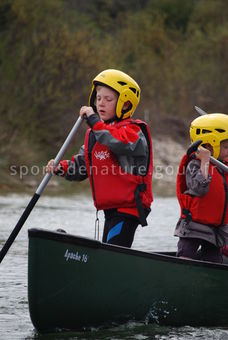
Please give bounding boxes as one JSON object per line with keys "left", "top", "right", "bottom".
{"left": 85, "top": 119, "right": 153, "bottom": 219}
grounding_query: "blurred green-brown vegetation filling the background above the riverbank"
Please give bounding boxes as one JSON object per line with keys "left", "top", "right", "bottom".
{"left": 0, "top": 0, "right": 228, "bottom": 191}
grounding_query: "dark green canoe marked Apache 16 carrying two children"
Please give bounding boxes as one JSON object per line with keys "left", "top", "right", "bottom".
{"left": 28, "top": 229, "right": 228, "bottom": 332}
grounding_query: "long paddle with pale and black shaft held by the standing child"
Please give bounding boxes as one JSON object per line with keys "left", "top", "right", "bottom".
{"left": 0, "top": 117, "right": 82, "bottom": 263}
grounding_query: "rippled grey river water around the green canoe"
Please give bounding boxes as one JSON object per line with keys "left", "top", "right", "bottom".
{"left": 0, "top": 194, "right": 228, "bottom": 340}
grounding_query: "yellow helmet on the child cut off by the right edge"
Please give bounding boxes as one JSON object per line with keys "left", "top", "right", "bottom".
{"left": 190, "top": 113, "right": 228, "bottom": 159}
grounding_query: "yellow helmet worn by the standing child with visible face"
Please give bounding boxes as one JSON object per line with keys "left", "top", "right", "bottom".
{"left": 89, "top": 69, "right": 140, "bottom": 119}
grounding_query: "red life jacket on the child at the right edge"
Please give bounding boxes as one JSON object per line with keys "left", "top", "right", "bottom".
{"left": 176, "top": 155, "right": 228, "bottom": 227}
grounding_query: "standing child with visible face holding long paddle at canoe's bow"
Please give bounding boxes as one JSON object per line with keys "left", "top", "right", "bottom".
{"left": 46, "top": 69, "right": 153, "bottom": 247}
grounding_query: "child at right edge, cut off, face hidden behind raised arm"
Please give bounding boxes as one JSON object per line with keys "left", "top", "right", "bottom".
{"left": 174, "top": 113, "right": 228, "bottom": 263}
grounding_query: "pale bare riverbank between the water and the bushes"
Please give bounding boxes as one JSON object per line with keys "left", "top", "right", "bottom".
{"left": 0, "top": 136, "right": 186, "bottom": 197}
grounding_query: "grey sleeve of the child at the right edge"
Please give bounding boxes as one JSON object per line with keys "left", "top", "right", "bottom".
{"left": 186, "top": 159, "right": 211, "bottom": 196}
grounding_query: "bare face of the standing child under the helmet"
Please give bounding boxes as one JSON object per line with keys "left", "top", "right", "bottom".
{"left": 96, "top": 86, "right": 118, "bottom": 121}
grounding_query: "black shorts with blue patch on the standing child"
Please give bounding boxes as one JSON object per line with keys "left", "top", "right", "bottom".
{"left": 102, "top": 209, "right": 139, "bottom": 248}
